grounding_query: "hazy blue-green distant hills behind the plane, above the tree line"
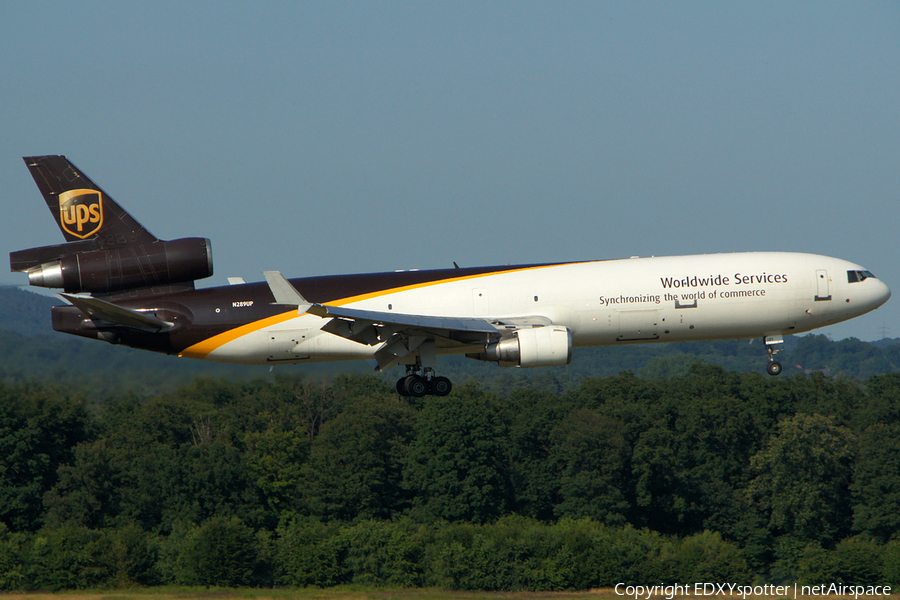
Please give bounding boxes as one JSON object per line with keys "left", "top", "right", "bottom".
{"left": 0, "top": 286, "right": 900, "bottom": 397}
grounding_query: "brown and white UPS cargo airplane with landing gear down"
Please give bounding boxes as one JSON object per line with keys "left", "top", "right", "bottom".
{"left": 10, "top": 156, "right": 891, "bottom": 397}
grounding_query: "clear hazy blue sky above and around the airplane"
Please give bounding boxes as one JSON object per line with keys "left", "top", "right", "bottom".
{"left": 0, "top": 1, "right": 900, "bottom": 340}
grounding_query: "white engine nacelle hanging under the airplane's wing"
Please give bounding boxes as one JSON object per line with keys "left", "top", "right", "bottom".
{"left": 466, "top": 326, "right": 572, "bottom": 367}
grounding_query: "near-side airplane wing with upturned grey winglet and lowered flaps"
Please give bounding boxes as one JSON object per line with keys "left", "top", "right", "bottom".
{"left": 265, "top": 271, "right": 551, "bottom": 370}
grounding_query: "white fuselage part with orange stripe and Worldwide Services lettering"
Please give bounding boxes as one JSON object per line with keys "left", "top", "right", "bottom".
{"left": 182, "top": 252, "right": 890, "bottom": 364}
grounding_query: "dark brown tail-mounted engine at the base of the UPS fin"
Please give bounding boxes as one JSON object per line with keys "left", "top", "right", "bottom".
{"left": 23, "top": 238, "right": 213, "bottom": 293}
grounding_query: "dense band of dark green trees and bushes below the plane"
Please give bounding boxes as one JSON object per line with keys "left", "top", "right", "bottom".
{"left": 0, "top": 364, "right": 900, "bottom": 590}
